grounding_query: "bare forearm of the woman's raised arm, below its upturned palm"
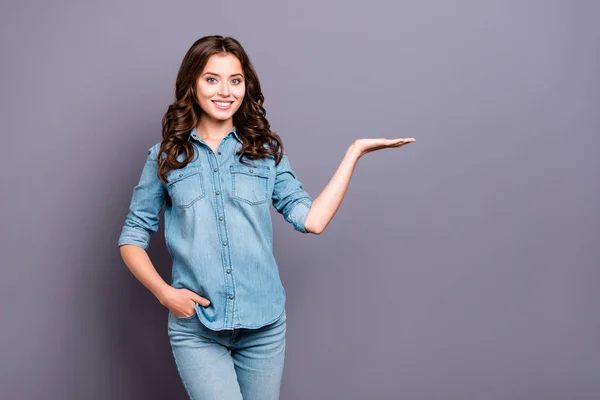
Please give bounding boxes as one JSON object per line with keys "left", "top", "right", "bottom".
{"left": 304, "top": 145, "right": 360, "bottom": 234}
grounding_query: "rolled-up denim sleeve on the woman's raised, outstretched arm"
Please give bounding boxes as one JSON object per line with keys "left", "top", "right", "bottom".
{"left": 272, "top": 152, "right": 313, "bottom": 233}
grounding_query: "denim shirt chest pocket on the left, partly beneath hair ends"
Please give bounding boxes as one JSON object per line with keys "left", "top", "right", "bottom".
{"left": 165, "top": 167, "right": 204, "bottom": 208}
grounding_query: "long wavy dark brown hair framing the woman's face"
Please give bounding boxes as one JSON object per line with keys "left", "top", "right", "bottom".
{"left": 158, "top": 35, "right": 284, "bottom": 182}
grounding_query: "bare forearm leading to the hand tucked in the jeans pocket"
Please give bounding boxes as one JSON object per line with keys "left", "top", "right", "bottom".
{"left": 119, "top": 244, "right": 171, "bottom": 304}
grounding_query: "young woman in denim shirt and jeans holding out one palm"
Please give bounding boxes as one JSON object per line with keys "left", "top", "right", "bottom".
{"left": 118, "top": 36, "right": 415, "bottom": 400}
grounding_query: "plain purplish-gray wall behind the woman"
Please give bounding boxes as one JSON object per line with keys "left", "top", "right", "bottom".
{"left": 0, "top": 0, "right": 600, "bottom": 400}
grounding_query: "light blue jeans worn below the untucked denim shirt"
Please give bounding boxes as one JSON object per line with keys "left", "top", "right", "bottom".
{"left": 168, "top": 309, "right": 286, "bottom": 400}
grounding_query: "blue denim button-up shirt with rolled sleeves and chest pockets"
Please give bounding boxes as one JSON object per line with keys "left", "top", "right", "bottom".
{"left": 118, "top": 127, "right": 313, "bottom": 330}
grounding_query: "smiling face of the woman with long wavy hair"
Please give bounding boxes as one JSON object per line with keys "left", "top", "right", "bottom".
{"left": 196, "top": 53, "right": 246, "bottom": 121}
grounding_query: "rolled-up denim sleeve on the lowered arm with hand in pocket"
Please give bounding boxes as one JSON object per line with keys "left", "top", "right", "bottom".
{"left": 118, "top": 144, "right": 165, "bottom": 249}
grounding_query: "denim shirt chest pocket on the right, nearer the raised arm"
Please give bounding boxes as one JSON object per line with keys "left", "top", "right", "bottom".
{"left": 229, "top": 165, "right": 271, "bottom": 205}
